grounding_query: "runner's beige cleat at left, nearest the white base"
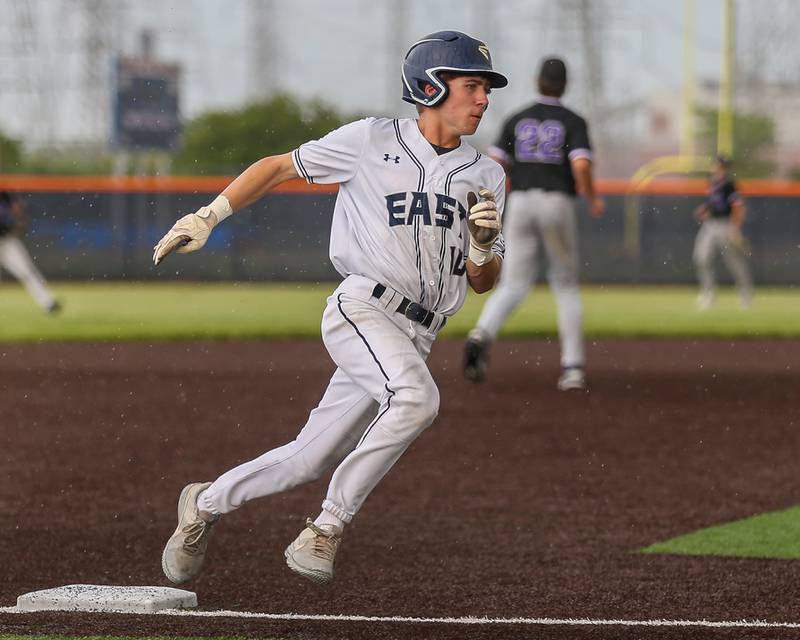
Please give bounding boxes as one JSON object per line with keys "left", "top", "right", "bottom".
{"left": 161, "top": 482, "right": 219, "bottom": 584}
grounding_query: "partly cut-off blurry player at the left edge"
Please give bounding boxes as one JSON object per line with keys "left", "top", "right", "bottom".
{"left": 0, "top": 191, "right": 61, "bottom": 314}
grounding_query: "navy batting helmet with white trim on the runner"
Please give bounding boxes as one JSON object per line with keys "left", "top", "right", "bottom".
{"left": 403, "top": 31, "right": 508, "bottom": 107}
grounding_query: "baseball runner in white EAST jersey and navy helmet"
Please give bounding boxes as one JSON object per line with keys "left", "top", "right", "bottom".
{"left": 153, "top": 31, "right": 508, "bottom": 584}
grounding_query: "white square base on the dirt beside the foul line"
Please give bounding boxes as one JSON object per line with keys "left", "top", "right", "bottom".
{"left": 17, "top": 584, "right": 197, "bottom": 613}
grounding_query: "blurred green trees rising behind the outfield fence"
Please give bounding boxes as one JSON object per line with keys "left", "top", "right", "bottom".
{"left": 0, "top": 93, "right": 788, "bottom": 179}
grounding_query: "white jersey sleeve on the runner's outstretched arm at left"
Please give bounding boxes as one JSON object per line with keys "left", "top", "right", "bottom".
{"left": 292, "top": 118, "right": 372, "bottom": 184}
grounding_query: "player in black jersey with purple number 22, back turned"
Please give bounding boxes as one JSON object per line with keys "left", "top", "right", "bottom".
{"left": 464, "top": 58, "right": 604, "bottom": 391}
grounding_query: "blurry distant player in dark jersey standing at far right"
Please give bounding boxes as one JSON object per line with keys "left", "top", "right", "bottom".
{"left": 694, "top": 156, "right": 753, "bottom": 311}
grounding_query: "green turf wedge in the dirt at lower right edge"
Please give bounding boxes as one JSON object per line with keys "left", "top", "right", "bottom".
{"left": 641, "top": 507, "right": 800, "bottom": 560}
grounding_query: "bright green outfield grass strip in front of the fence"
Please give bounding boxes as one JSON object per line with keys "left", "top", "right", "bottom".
{"left": 0, "top": 282, "right": 800, "bottom": 342}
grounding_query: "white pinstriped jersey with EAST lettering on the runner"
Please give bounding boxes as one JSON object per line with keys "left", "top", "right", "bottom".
{"left": 292, "top": 118, "right": 505, "bottom": 316}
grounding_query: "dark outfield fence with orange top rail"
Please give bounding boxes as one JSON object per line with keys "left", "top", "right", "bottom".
{"left": 0, "top": 176, "right": 800, "bottom": 285}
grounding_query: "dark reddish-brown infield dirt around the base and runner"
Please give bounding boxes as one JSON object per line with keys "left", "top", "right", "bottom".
{"left": 0, "top": 340, "right": 800, "bottom": 639}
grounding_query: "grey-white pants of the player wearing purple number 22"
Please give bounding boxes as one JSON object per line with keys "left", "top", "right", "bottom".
{"left": 476, "top": 189, "right": 586, "bottom": 367}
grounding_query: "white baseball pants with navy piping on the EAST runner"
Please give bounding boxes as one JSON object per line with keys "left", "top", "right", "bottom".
{"left": 199, "top": 275, "right": 441, "bottom": 522}
